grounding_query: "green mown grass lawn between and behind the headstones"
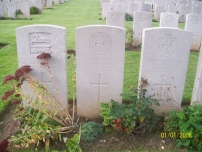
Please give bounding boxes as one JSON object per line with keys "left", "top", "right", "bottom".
{"left": 0, "top": 0, "right": 198, "bottom": 113}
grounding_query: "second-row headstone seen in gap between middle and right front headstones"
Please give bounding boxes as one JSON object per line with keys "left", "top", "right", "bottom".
{"left": 133, "top": 11, "right": 152, "bottom": 46}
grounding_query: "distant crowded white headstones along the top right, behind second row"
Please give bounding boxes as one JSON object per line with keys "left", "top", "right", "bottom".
{"left": 101, "top": 0, "right": 202, "bottom": 22}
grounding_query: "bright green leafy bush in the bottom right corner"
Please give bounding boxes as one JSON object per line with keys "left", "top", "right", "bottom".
{"left": 164, "top": 103, "right": 202, "bottom": 151}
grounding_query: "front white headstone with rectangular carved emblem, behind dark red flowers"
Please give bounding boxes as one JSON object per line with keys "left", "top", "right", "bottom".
{"left": 16, "top": 25, "right": 68, "bottom": 113}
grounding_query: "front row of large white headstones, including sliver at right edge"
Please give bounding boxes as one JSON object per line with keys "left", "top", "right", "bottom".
{"left": 16, "top": 25, "right": 202, "bottom": 118}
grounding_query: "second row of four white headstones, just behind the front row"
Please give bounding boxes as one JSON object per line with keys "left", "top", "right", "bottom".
{"left": 106, "top": 11, "right": 202, "bottom": 51}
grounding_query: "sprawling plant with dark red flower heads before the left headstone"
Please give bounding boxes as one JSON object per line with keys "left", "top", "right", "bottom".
{"left": 1, "top": 53, "right": 77, "bottom": 148}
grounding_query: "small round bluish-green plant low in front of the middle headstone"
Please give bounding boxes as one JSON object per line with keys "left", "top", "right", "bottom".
{"left": 81, "top": 121, "right": 103, "bottom": 141}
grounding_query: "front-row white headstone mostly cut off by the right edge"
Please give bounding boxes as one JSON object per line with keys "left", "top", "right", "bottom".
{"left": 191, "top": 42, "right": 202, "bottom": 104}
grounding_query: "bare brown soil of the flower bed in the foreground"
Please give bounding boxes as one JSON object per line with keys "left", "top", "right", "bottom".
{"left": 0, "top": 104, "right": 187, "bottom": 152}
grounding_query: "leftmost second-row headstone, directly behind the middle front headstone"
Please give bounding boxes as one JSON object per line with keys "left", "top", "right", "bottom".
{"left": 106, "top": 11, "right": 125, "bottom": 28}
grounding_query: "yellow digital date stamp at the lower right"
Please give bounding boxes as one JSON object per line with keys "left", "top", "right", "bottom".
{"left": 160, "top": 132, "right": 192, "bottom": 139}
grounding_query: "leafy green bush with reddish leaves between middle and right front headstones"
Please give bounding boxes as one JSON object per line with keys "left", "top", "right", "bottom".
{"left": 100, "top": 79, "right": 159, "bottom": 134}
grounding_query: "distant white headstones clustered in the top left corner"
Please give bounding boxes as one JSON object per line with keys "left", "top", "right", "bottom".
{"left": 0, "top": 0, "right": 68, "bottom": 19}
